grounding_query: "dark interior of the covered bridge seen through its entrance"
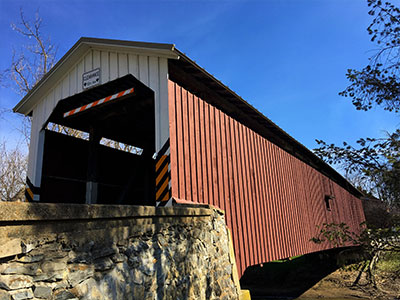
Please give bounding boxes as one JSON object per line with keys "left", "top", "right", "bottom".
{"left": 40, "top": 75, "right": 155, "bottom": 205}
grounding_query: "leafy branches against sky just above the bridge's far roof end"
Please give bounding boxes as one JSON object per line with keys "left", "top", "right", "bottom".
{"left": 314, "top": 130, "right": 400, "bottom": 206}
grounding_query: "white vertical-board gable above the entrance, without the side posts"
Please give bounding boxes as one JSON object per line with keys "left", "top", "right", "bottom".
{"left": 32, "top": 49, "right": 168, "bottom": 136}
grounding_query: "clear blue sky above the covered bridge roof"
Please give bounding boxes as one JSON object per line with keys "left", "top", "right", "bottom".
{"left": 0, "top": 0, "right": 400, "bottom": 149}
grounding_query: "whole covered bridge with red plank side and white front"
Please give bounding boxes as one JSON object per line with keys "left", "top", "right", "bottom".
{"left": 14, "top": 38, "right": 364, "bottom": 274}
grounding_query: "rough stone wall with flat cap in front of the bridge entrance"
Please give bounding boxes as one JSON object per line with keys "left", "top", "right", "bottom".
{"left": 0, "top": 203, "right": 238, "bottom": 300}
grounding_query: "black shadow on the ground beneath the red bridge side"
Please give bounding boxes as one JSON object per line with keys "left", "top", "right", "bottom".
{"left": 240, "top": 248, "right": 357, "bottom": 299}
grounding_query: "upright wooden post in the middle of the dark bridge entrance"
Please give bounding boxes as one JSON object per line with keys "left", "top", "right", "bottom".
{"left": 86, "top": 125, "right": 101, "bottom": 204}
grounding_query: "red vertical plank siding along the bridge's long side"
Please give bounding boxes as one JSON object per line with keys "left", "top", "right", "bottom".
{"left": 168, "top": 81, "right": 364, "bottom": 275}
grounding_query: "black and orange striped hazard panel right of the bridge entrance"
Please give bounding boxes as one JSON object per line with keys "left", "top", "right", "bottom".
{"left": 156, "top": 139, "right": 171, "bottom": 206}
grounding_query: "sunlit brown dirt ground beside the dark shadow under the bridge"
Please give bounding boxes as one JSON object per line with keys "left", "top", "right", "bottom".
{"left": 298, "top": 270, "right": 400, "bottom": 300}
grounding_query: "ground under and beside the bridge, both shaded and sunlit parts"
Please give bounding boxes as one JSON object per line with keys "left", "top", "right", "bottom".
{"left": 240, "top": 249, "right": 400, "bottom": 300}
